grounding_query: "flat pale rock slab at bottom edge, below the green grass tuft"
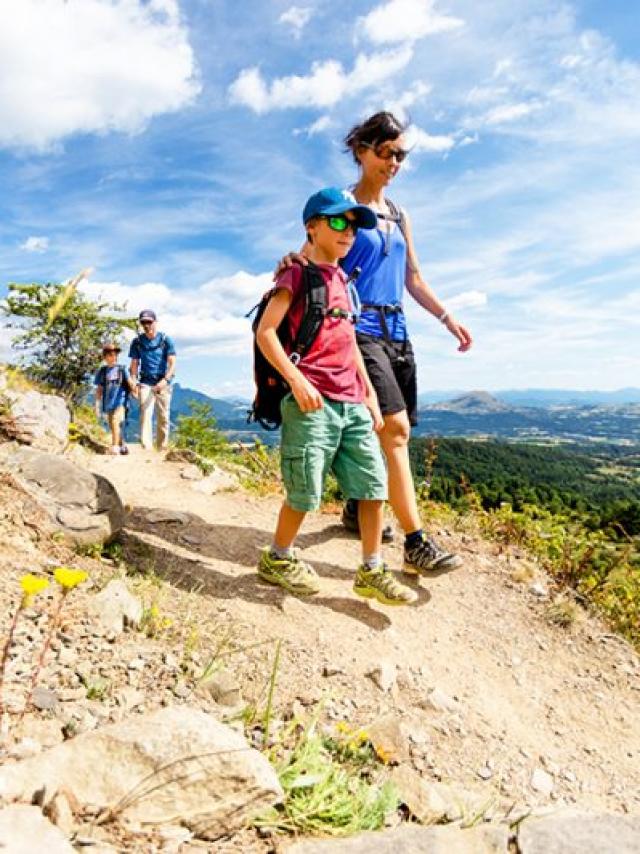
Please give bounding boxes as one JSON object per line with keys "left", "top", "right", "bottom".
{"left": 284, "top": 824, "right": 509, "bottom": 854}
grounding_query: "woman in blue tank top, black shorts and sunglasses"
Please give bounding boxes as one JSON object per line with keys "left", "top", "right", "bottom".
{"left": 279, "top": 107, "right": 472, "bottom": 575}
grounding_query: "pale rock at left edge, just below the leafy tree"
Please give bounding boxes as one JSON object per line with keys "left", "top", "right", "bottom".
{"left": 3, "top": 389, "right": 70, "bottom": 453}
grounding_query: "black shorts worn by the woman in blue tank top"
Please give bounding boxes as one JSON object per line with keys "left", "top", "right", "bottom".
{"left": 356, "top": 332, "right": 418, "bottom": 427}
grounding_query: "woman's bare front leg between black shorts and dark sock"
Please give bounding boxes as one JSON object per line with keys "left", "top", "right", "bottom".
{"left": 378, "top": 409, "right": 422, "bottom": 534}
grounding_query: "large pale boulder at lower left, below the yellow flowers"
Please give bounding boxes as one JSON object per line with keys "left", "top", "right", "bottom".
{"left": 0, "top": 706, "right": 283, "bottom": 850}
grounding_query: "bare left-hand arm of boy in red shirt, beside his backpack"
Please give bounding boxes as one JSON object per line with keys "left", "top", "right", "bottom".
{"left": 256, "top": 288, "right": 323, "bottom": 412}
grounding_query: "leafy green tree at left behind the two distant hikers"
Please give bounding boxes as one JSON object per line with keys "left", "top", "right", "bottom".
{"left": 0, "top": 274, "right": 136, "bottom": 409}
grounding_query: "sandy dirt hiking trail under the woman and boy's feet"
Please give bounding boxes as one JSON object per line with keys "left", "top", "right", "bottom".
{"left": 89, "top": 446, "right": 640, "bottom": 813}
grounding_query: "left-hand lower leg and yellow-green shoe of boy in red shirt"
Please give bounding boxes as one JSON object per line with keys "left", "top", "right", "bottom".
{"left": 258, "top": 502, "right": 320, "bottom": 596}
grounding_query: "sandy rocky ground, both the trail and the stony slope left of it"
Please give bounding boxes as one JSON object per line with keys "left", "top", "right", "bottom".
{"left": 0, "top": 448, "right": 640, "bottom": 852}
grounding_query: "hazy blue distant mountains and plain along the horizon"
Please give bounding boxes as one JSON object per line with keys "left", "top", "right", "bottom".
{"left": 161, "top": 384, "right": 640, "bottom": 444}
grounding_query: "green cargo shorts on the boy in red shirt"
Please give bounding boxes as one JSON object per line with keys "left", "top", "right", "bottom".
{"left": 280, "top": 394, "right": 387, "bottom": 511}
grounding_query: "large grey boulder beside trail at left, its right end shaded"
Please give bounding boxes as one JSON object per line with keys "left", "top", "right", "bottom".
{"left": 0, "top": 442, "right": 125, "bottom": 545}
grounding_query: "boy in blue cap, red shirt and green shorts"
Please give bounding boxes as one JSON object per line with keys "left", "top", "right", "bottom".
{"left": 256, "top": 187, "right": 417, "bottom": 605}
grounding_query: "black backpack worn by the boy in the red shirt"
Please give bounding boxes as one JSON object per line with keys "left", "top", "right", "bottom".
{"left": 245, "top": 262, "right": 360, "bottom": 430}
